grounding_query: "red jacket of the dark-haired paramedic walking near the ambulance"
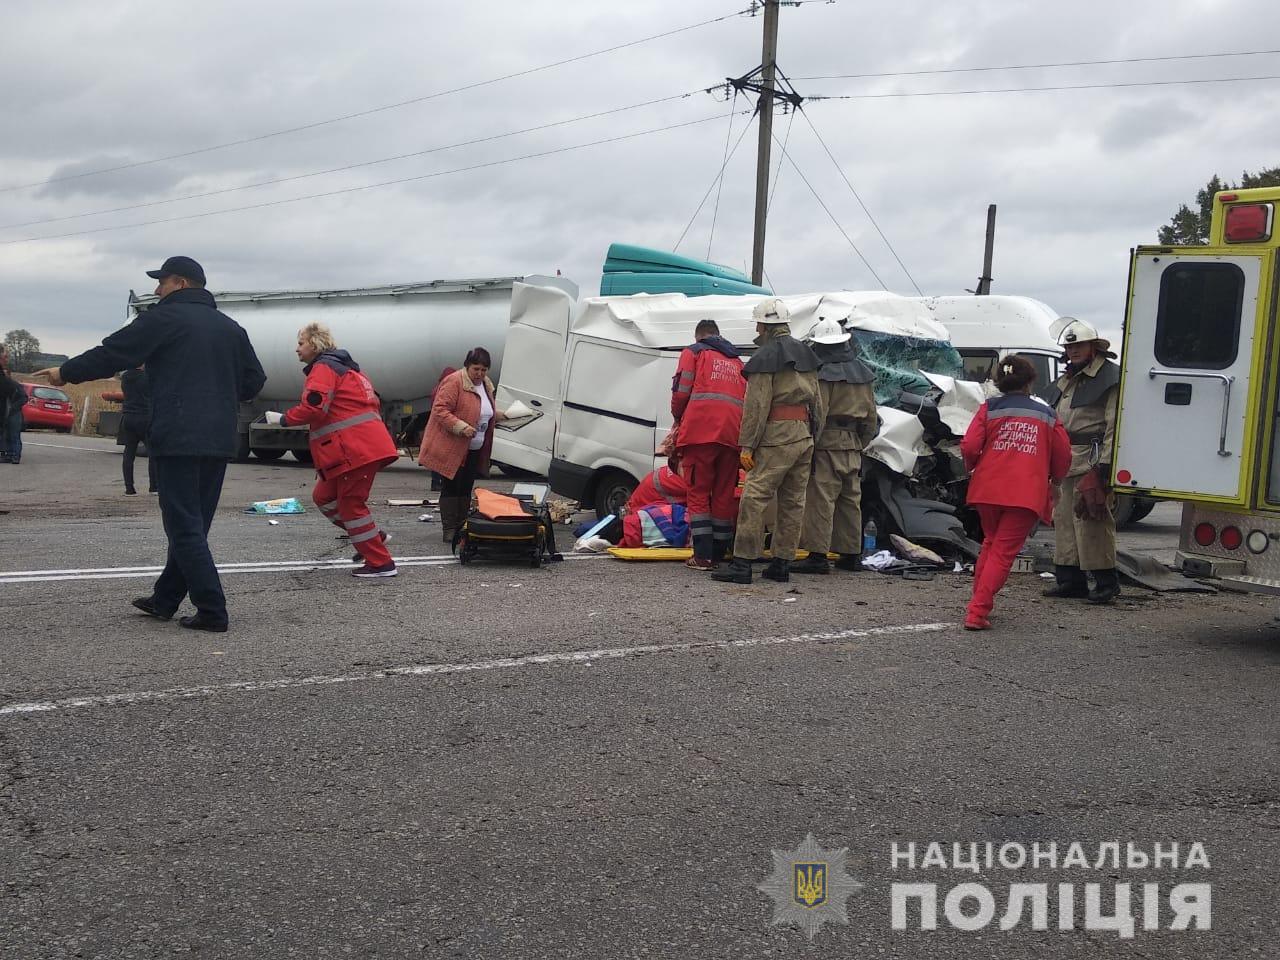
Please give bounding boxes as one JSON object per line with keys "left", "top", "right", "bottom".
{"left": 960, "top": 393, "right": 1071, "bottom": 524}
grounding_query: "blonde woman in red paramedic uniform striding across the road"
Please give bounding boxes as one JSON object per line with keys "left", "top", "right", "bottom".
{"left": 266, "top": 324, "right": 398, "bottom": 579}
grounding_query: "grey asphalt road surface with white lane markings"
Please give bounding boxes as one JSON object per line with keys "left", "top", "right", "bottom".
{"left": 0, "top": 434, "right": 1280, "bottom": 959}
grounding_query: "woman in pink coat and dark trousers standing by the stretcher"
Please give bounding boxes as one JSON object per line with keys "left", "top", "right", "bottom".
{"left": 417, "top": 347, "right": 506, "bottom": 543}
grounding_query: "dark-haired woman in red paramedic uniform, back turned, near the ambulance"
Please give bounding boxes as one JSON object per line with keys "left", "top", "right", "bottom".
{"left": 960, "top": 355, "right": 1071, "bottom": 630}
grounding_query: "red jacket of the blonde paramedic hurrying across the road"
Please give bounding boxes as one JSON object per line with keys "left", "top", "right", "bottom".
{"left": 282, "top": 349, "right": 399, "bottom": 480}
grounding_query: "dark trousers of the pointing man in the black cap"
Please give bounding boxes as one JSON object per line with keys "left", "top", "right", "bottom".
{"left": 151, "top": 457, "right": 227, "bottom": 621}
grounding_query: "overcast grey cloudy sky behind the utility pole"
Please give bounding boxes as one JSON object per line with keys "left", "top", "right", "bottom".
{"left": 0, "top": 0, "right": 1280, "bottom": 353}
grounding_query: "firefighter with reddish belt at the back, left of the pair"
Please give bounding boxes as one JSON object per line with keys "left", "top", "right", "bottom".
{"left": 712, "top": 298, "right": 826, "bottom": 584}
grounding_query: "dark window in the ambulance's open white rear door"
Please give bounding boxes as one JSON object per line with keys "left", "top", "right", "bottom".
{"left": 1156, "top": 264, "right": 1244, "bottom": 370}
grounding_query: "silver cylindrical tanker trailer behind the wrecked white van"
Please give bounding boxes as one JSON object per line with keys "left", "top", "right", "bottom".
{"left": 127, "top": 276, "right": 577, "bottom": 462}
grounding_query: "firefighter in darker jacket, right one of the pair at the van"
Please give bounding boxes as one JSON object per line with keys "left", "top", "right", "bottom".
{"left": 791, "top": 320, "right": 879, "bottom": 573}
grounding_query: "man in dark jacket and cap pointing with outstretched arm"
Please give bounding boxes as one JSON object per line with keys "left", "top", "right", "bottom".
{"left": 37, "top": 257, "right": 266, "bottom": 632}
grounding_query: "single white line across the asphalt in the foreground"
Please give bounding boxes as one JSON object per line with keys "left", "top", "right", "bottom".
{"left": 0, "top": 623, "right": 955, "bottom": 717}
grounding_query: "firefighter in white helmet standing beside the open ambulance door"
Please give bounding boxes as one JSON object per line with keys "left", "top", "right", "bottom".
{"left": 1044, "top": 316, "right": 1120, "bottom": 603}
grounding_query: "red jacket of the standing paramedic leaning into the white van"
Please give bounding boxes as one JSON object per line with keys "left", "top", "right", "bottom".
{"left": 671, "top": 337, "right": 746, "bottom": 451}
